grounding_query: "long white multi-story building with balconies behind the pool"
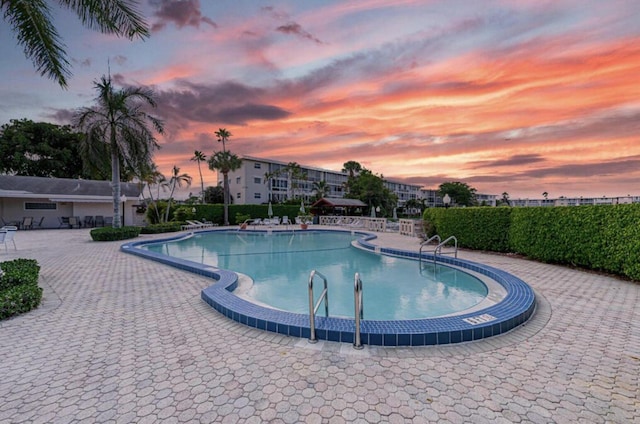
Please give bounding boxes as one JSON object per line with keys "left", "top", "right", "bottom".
{"left": 218, "top": 156, "right": 421, "bottom": 206}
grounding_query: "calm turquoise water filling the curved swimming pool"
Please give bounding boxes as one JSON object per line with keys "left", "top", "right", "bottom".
{"left": 142, "top": 231, "right": 487, "bottom": 320}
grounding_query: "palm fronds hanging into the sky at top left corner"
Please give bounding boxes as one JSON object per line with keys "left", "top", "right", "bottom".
{"left": 0, "top": 0, "right": 150, "bottom": 88}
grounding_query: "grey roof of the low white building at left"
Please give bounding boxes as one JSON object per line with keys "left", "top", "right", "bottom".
{"left": 0, "top": 175, "right": 140, "bottom": 201}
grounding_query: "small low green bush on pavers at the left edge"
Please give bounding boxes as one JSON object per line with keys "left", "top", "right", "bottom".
{"left": 0, "top": 259, "right": 42, "bottom": 320}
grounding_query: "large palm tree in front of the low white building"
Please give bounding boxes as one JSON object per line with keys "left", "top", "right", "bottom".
{"left": 74, "top": 76, "right": 164, "bottom": 228}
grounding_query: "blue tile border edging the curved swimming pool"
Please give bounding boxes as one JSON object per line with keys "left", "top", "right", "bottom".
{"left": 120, "top": 229, "right": 536, "bottom": 346}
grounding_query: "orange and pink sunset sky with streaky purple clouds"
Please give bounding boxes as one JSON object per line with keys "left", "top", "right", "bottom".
{"left": 0, "top": 0, "right": 640, "bottom": 199}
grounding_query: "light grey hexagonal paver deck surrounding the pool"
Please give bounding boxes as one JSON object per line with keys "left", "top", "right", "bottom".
{"left": 0, "top": 230, "right": 640, "bottom": 424}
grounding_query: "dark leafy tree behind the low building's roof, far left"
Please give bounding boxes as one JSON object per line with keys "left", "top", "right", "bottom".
{"left": 0, "top": 119, "right": 91, "bottom": 179}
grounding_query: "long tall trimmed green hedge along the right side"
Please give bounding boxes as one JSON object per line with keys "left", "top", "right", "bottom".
{"left": 424, "top": 204, "right": 640, "bottom": 280}
